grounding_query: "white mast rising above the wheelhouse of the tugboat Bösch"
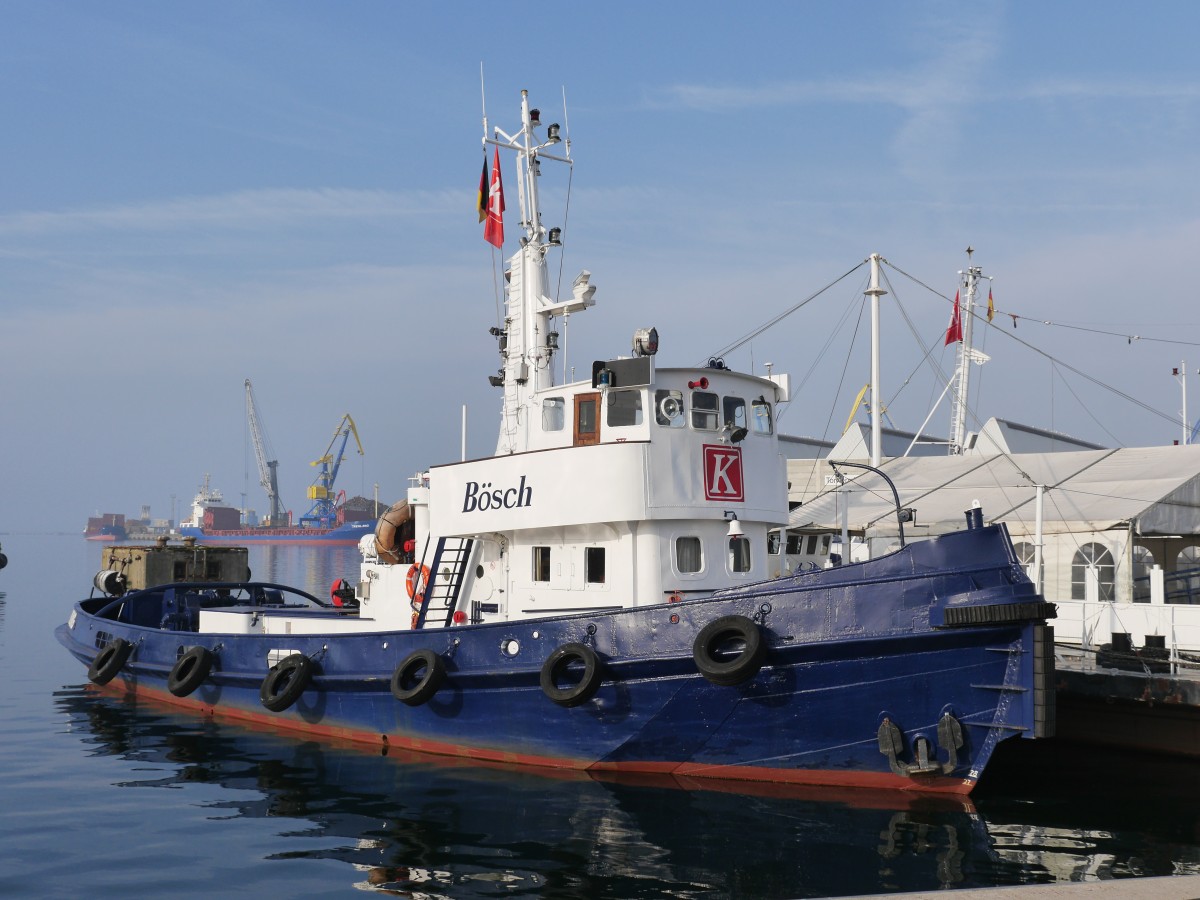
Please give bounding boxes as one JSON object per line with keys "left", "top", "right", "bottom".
{"left": 484, "top": 91, "right": 595, "bottom": 455}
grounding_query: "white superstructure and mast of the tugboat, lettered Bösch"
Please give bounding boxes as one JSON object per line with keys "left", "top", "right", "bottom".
{"left": 358, "top": 94, "right": 787, "bottom": 624}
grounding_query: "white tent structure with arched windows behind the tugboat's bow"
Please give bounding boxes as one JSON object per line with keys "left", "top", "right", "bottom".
{"left": 787, "top": 445, "right": 1200, "bottom": 649}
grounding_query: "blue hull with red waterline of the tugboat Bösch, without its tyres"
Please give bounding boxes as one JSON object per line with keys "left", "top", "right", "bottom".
{"left": 56, "top": 526, "right": 1054, "bottom": 793}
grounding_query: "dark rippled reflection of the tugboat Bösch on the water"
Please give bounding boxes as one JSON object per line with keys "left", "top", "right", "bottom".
{"left": 56, "top": 688, "right": 1012, "bottom": 898}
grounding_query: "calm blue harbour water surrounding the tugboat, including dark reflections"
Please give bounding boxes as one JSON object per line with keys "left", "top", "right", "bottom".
{"left": 7, "top": 535, "right": 1200, "bottom": 899}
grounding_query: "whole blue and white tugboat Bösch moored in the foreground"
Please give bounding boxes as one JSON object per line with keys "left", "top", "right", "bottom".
{"left": 56, "top": 92, "right": 1054, "bottom": 794}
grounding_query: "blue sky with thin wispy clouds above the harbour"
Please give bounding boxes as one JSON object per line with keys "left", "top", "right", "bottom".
{"left": 0, "top": 0, "right": 1200, "bottom": 533}
